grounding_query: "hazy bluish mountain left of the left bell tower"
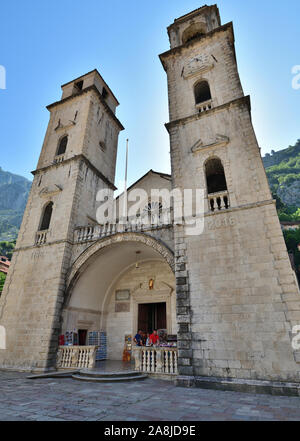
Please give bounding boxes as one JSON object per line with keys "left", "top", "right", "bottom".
{"left": 0, "top": 167, "right": 31, "bottom": 241}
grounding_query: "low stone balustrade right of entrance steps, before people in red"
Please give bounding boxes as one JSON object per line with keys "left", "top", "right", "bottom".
{"left": 133, "top": 346, "right": 178, "bottom": 375}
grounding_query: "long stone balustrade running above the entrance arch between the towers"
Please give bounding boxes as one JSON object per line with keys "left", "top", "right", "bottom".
{"left": 74, "top": 223, "right": 169, "bottom": 243}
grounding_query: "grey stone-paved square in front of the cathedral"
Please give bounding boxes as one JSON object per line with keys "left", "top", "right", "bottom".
{"left": 0, "top": 371, "right": 300, "bottom": 421}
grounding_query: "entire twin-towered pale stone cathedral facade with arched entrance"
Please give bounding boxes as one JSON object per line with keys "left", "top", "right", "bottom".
{"left": 0, "top": 5, "right": 300, "bottom": 385}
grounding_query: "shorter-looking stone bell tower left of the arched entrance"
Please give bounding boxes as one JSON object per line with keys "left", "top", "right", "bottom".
{"left": 0, "top": 70, "right": 123, "bottom": 370}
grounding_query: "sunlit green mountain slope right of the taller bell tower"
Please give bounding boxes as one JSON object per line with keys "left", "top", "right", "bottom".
{"left": 263, "top": 139, "right": 300, "bottom": 207}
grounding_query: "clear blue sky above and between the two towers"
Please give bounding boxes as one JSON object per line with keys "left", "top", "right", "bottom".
{"left": 0, "top": 0, "right": 300, "bottom": 184}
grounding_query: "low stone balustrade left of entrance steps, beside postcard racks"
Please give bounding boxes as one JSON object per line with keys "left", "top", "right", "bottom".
{"left": 56, "top": 346, "right": 98, "bottom": 369}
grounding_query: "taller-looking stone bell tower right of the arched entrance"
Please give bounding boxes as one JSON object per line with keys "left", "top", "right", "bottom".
{"left": 160, "top": 5, "right": 300, "bottom": 385}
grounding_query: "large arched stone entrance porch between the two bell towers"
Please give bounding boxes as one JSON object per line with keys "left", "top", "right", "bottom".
{"left": 62, "top": 233, "right": 176, "bottom": 360}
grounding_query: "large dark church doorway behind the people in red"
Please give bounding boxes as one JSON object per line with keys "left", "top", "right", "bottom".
{"left": 138, "top": 302, "right": 167, "bottom": 333}
